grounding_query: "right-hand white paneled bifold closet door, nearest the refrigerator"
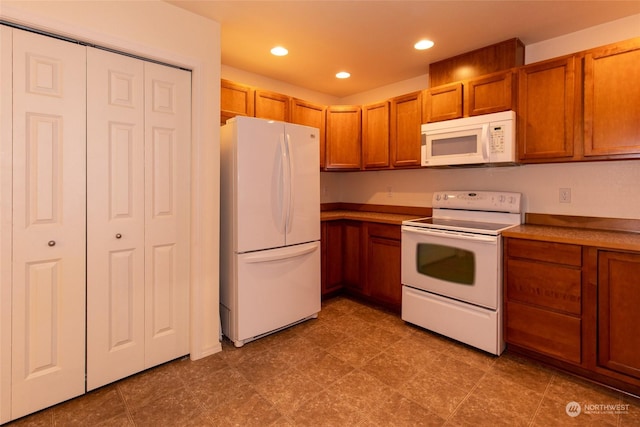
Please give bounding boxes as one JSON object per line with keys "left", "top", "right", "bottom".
{"left": 87, "top": 48, "right": 191, "bottom": 390}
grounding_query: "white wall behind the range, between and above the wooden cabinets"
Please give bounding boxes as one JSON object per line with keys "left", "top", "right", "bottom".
{"left": 321, "top": 15, "right": 640, "bottom": 218}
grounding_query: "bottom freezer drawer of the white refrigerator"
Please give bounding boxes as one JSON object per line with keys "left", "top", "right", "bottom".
{"left": 221, "top": 242, "right": 320, "bottom": 347}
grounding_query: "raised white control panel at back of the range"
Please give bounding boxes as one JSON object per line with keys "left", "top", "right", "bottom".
{"left": 432, "top": 191, "right": 522, "bottom": 213}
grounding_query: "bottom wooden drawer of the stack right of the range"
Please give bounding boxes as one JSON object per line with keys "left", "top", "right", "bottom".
{"left": 505, "top": 302, "right": 582, "bottom": 364}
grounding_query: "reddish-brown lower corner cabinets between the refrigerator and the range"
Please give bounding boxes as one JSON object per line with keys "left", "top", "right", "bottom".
{"left": 321, "top": 220, "right": 402, "bottom": 312}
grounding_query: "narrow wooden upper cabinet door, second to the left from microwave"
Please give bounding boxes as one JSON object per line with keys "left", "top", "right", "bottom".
{"left": 362, "top": 101, "right": 391, "bottom": 169}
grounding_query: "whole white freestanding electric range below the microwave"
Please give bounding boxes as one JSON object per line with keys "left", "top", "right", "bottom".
{"left": 401, "top": 191, "right": 522, "bottom": 355}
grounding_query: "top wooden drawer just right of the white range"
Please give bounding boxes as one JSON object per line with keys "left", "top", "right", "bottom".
{"left": 507, "top": 239, "right": 582, "bottom": 267}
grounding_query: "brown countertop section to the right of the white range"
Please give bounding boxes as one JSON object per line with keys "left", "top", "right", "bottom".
{"left": 502, "top": 224, "right": 640, "bottom": 252}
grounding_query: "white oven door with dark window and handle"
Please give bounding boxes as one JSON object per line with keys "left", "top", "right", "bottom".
{"left": 402, "top": 225, "right": 502, "bottom": 310}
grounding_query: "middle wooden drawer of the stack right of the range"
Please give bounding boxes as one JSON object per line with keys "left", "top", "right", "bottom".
{"left": 506, "top": 259, "right": 581, "bottom": 315}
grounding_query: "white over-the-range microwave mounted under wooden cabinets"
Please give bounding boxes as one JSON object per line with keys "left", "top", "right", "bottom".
{"left": 421, "top": 111, "right": 516, "bottom": 166}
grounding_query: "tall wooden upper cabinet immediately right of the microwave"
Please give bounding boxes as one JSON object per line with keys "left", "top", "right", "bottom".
{"left": 517, "top": 56, "right": 579, "bottom": 163}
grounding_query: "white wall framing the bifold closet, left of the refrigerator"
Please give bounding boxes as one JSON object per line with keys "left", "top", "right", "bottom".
{"left": 0, "top": 0, "right": 221, "bottom": 368}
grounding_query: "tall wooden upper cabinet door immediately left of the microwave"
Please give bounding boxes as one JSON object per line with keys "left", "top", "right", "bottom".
{"left": 390, "top": 91, "right": 422, "bottom": 168}
